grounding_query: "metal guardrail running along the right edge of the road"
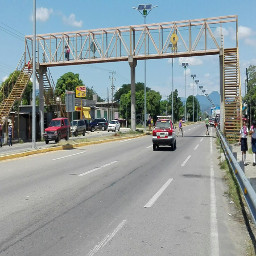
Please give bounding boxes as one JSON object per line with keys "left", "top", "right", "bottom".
{"left": 216, "top": 128, "right": 256, "bottom": 224}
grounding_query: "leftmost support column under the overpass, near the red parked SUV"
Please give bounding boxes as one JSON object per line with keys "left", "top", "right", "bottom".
{"left": 37, "top": 66, "right": 47, "bottom": 140}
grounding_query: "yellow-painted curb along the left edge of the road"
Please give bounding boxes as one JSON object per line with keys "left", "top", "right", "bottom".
{"left": 0, "top": 134, "right": 146, "bottom": 162}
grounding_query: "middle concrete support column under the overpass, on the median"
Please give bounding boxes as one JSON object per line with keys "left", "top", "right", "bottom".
{"left": 128, "top": 56, "right": 137, "bottom": 131}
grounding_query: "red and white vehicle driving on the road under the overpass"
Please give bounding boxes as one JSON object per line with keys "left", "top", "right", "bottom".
{"left": 152, "top": 117, "right": 176, "bottom": 151}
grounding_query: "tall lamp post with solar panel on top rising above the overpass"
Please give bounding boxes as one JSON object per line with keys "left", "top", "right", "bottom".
{"left": 132, "top": 4, "right": 158, "bottom": 129}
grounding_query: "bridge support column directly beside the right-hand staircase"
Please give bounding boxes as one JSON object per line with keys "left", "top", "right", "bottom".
{"left": 219, "top": 48, "right": 225, "bottom": 132}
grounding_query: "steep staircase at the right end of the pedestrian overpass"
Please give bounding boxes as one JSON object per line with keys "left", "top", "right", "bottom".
{"left": 223, "top": 48, "right": 242, "bottom": 141}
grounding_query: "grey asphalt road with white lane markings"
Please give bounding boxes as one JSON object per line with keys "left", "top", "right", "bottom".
{"left": 0, "top": 124, "right": 246, "bottom": 256}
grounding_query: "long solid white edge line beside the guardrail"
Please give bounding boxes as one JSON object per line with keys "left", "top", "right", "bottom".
{"left": 210, "top": 137, "right": 219, "bottom": 256}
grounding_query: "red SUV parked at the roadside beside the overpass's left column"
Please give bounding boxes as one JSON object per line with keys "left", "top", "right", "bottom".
{"left": 44, "top": 117, "right": 70, "bottom": 144}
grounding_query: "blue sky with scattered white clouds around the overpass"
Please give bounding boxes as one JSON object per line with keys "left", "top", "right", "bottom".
{"left": 0, "top": 0, "right": 256, "bottom": 99}
